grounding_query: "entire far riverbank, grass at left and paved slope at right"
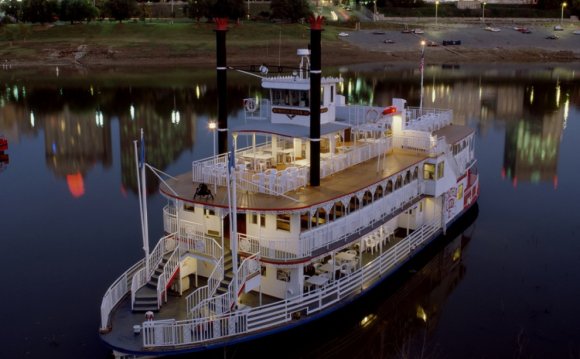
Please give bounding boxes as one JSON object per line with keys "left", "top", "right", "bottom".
{"left": 0, "top": 22, "right": 580, "bottom": 67}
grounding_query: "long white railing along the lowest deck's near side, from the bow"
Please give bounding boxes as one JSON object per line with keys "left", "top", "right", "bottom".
{"left": 143, "top": 220, "right": 440, "bottom": 348}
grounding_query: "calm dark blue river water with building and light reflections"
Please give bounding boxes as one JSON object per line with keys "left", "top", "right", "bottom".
{"left": 0, "top": 65, "right": 580, "bottom": 359}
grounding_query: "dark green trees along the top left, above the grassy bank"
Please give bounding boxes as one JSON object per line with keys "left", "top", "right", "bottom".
{"left": 0, "top": 0, "right": 311, "bottom": 23}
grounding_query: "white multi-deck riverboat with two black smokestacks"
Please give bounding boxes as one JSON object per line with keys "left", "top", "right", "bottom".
{"left": 100, "top": 18, "right": 479, "bottom": 357}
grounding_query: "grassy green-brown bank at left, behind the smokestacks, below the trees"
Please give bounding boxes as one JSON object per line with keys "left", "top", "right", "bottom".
{"left": 0, "top": 21, "right": 340, "bottom": 66}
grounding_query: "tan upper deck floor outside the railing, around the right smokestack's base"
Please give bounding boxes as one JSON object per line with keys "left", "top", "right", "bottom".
{"left": 161, "top": 151, "right": 427, "bottom": 211}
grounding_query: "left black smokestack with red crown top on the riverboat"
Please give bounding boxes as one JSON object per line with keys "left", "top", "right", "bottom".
{"left": 215, "top": 18, "right": 228, "bottom": 154}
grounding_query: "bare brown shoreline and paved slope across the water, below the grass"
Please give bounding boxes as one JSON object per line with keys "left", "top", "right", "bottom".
{"left": 0, "top": 24, "right": 580, "bottom": 69}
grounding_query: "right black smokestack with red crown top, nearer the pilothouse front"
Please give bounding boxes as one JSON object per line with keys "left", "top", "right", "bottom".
{"left": 310, "top": 16, "right": 322, "bottom": 187}
